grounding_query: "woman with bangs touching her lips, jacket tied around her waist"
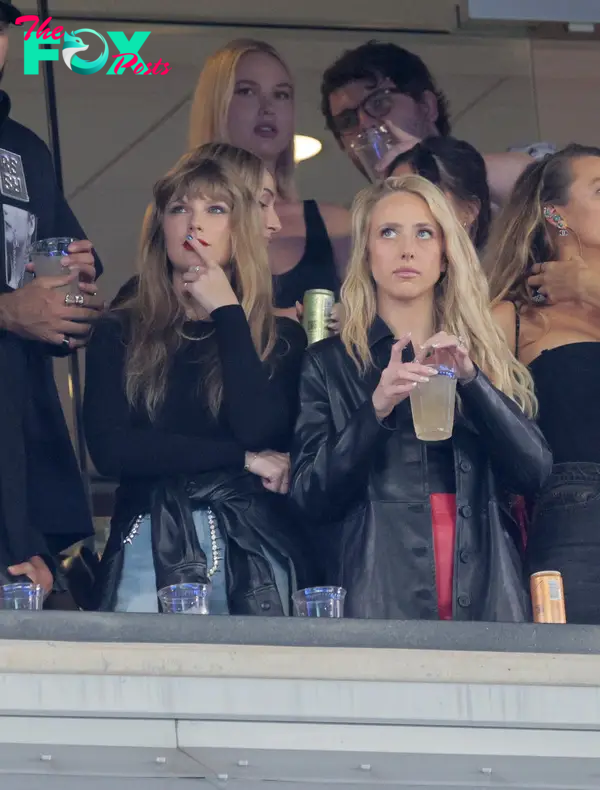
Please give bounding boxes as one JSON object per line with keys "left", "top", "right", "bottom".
{"left": 84, "top": 144, "right": 306, "bottom": 615}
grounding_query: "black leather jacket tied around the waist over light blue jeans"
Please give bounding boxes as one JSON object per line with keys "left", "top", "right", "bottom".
{"left": 92, "top": 470, "right": 307, "bottom": 617}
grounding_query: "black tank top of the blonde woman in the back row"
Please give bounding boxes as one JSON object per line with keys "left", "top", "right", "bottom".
{"left": 273, "top": 200, "right": 340, "bottom": 308}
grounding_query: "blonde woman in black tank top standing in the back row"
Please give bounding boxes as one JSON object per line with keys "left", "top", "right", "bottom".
{"left": 189, "top": 39, "right": 350, "bottom": 318}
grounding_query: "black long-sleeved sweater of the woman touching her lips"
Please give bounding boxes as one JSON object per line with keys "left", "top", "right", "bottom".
{"left": 84, "top": 305, "right": 306, "bottom": 512}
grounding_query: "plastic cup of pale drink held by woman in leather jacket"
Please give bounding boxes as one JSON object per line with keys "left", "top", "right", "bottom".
{"left": 410, "top": 351, "right": 456, "bottom": 442}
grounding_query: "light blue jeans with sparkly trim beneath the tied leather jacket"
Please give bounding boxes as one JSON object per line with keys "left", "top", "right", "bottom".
{"left": 115, "top": 509, "right": 290, "bottom": 615}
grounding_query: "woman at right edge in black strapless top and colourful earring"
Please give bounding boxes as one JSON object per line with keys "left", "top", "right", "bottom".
{"left": 484, "top": 145, "right": 600, "bottom": 623}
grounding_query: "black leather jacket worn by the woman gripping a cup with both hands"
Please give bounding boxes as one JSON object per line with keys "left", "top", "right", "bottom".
{"left": 291, "top": 318, "right": 552, "bottom": 622}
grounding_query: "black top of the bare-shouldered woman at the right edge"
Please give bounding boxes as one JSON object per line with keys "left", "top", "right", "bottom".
{"left": 515, "top": 304, "right": 600, "bottom": 464}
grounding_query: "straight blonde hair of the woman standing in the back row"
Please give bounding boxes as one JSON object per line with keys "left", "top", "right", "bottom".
{"left": 189, "top": 38, "right": 296, "bottom": 200}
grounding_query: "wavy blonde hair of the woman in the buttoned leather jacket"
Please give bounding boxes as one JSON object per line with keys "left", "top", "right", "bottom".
{"left": 341, "top": 175, "right": 537, "bottom": 416}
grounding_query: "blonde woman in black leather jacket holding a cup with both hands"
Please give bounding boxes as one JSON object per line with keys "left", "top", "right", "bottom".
{"left": 291, "top": 175, "right": 552, "bottom": 621}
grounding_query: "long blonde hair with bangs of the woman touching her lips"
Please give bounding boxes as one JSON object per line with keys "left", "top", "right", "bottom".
{"left": 115, "top": 143, "right": 276, "bottom": 419}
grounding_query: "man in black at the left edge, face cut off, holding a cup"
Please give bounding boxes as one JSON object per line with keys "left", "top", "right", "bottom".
{"left": 0, "top": 0, "right": 102, "bottom": 587}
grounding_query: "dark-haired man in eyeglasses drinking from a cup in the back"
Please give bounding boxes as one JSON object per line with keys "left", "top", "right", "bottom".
{"left": 321, "top": 41, "right": 532, "bottom": 204}
